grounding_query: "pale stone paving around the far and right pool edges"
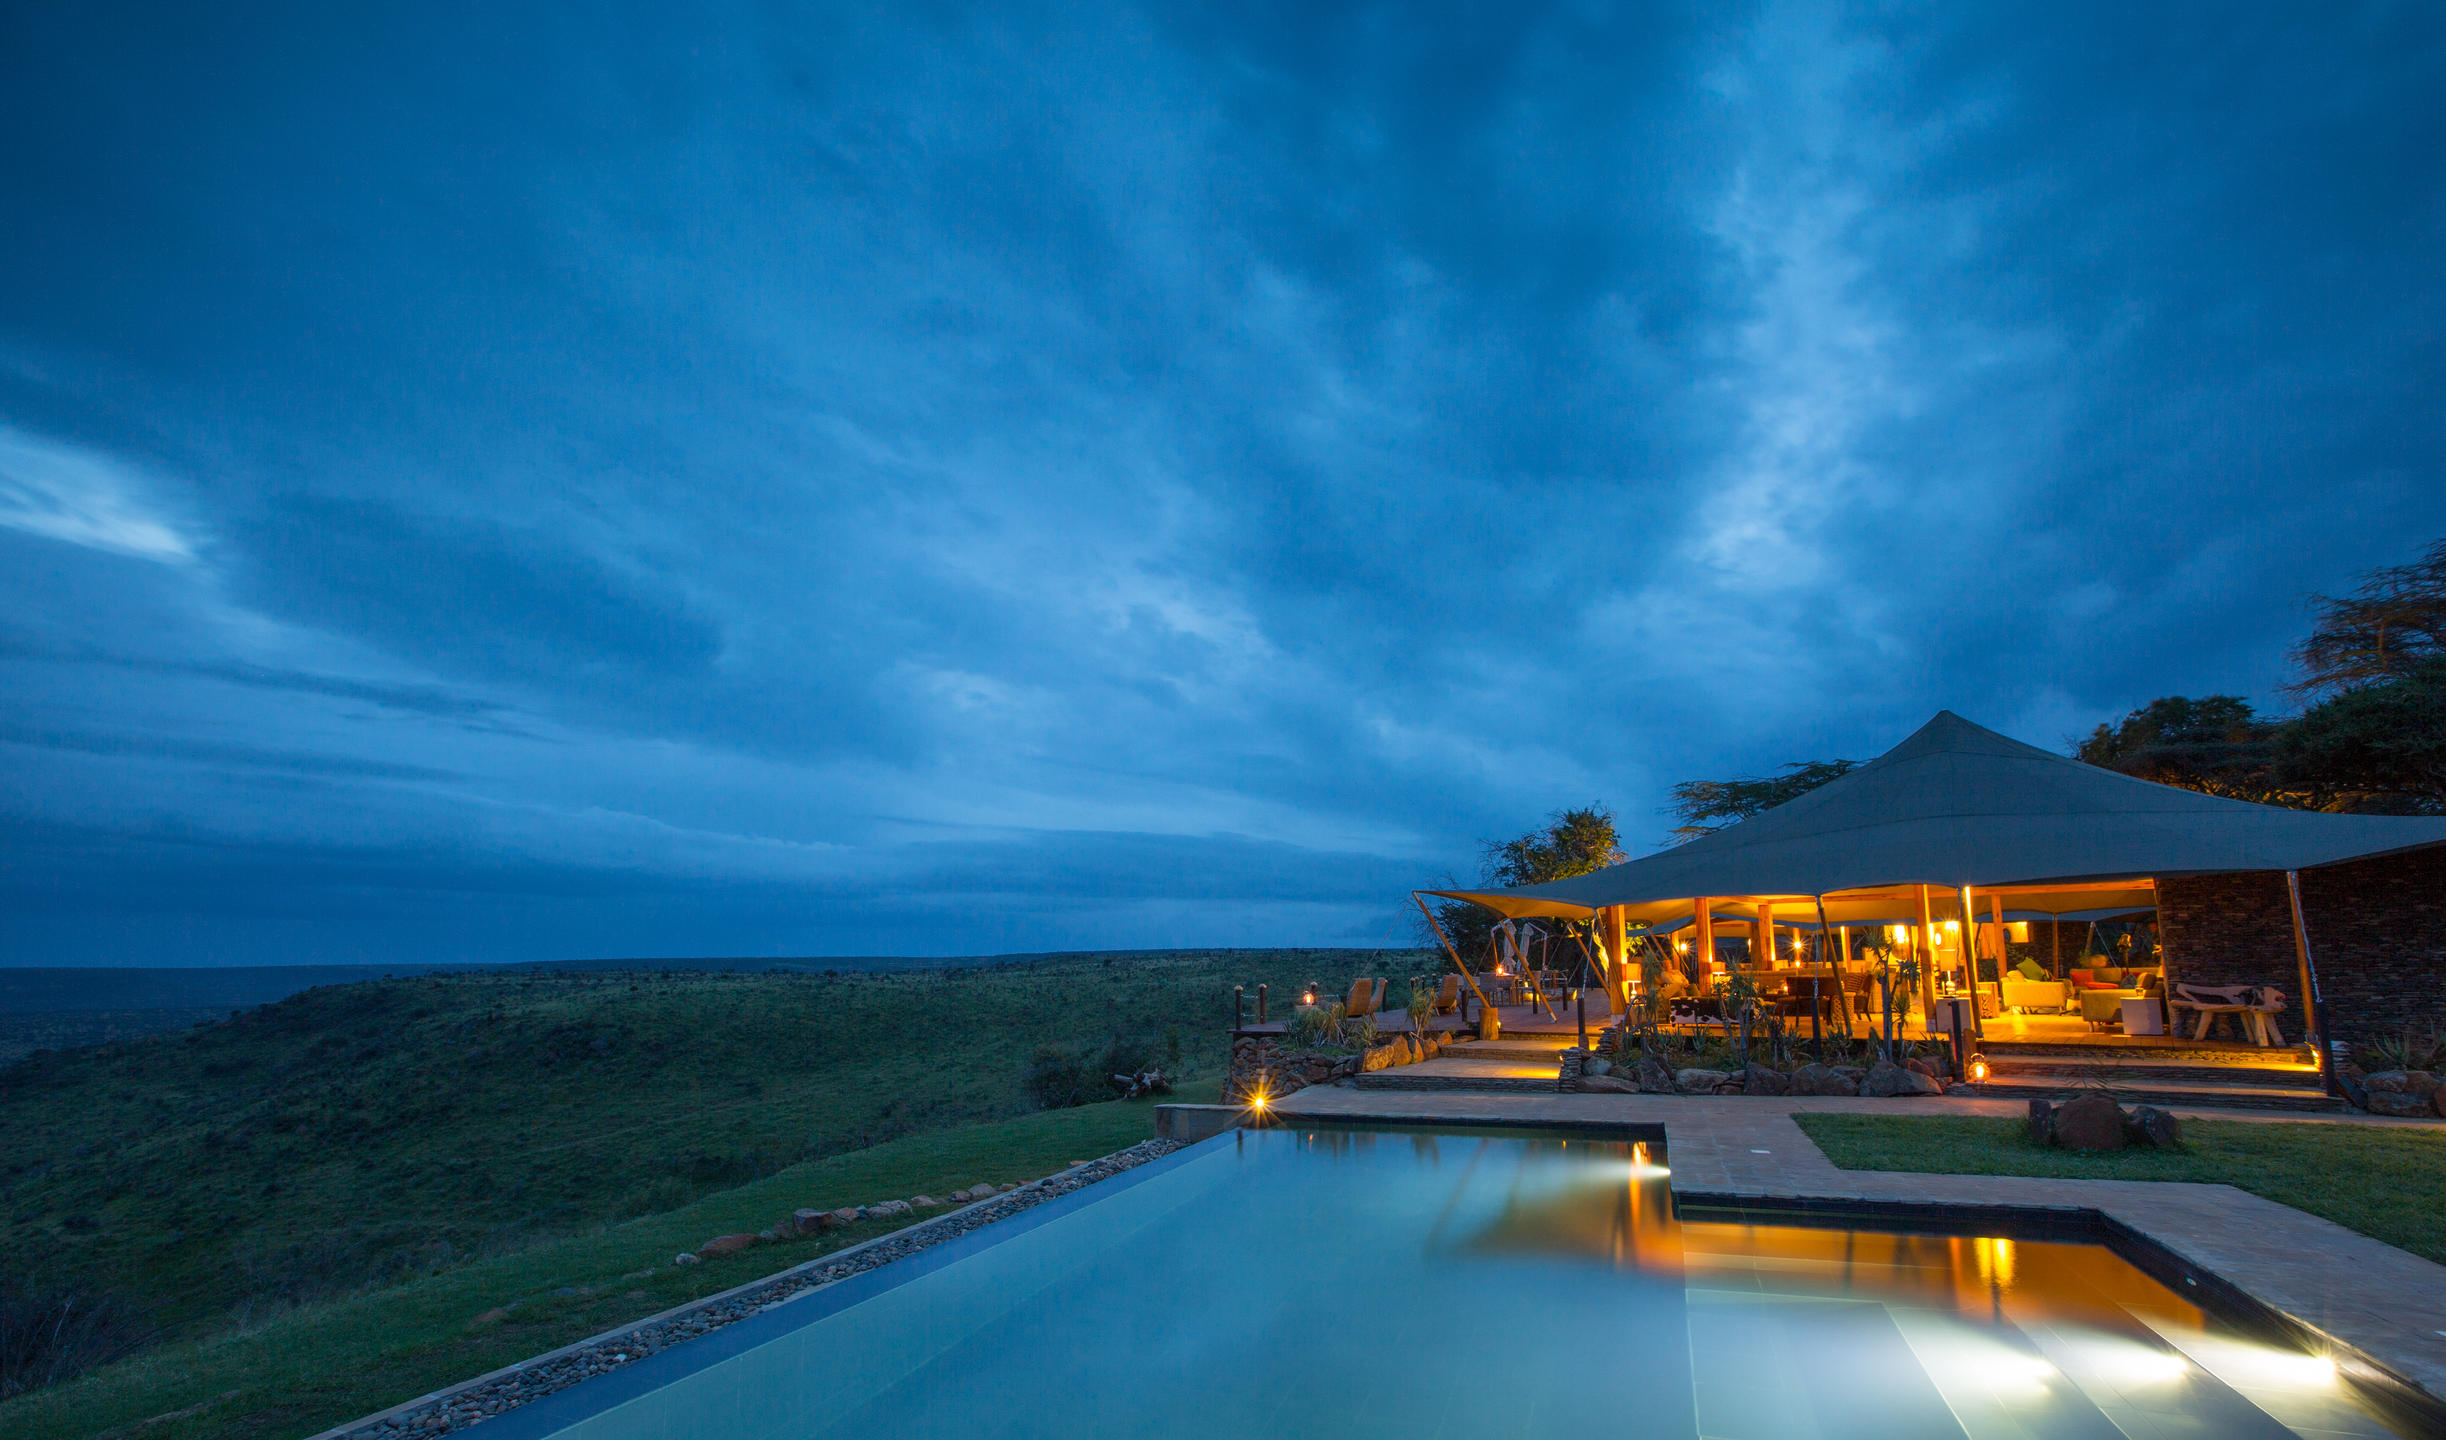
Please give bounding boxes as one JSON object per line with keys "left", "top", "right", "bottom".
{"left": 1274, "top": 1086, "right": 2446, "bottom": 1401}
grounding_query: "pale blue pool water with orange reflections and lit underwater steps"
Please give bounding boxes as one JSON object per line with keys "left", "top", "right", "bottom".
{"left": 506, "top": 1130, "right": 2395, "bottom": 1440}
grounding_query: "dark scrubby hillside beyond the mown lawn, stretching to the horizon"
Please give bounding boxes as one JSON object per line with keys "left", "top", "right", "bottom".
{"left": 0, "top": 951, "right": 1416, "bottom": 1340}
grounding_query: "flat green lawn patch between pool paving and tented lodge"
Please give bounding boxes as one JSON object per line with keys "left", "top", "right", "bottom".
{"left": 1793, "top": 1115, "right": 2446, "bottom": 1264}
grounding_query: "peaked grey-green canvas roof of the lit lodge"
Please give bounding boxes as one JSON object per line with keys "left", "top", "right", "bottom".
{"left": 1446, "top": 711, "right": 2446, "bottom": 914}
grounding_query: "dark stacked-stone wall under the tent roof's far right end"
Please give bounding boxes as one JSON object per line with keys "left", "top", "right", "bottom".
{"left": 2157, "top": 848, "right": 2446, "bottom": 1039}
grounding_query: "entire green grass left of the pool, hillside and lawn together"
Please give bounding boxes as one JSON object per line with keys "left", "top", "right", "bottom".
{"left": 0, "top": 951, "right": 1424, "bottom": 1438}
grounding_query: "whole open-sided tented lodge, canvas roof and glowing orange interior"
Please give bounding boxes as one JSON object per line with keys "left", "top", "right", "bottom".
{"left": 1419, "top": 711, "right": 2446, "bottom": 1063}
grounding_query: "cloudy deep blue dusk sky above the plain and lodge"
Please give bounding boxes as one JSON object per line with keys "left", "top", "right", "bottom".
{"left": 0, "top": 0, "right": 2446, "bottom": 966}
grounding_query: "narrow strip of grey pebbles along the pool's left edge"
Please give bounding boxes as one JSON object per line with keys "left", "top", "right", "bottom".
{"left": 311, "top": 1139, "right": 1186, "bottom": 1440}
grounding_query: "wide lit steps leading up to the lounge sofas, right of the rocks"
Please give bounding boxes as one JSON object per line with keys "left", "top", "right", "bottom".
{"left": 1947, "top": 1041, "right": 2346, "bottom": 1112}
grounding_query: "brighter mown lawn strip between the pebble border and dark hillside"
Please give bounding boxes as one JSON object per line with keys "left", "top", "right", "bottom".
{"left": 0, "top": 1081, "right": 1221, "bottom": 1440}
